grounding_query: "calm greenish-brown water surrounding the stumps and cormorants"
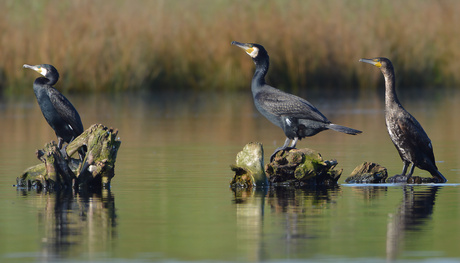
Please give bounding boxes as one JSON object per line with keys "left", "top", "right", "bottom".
{"left": 0, "top": 87, "right": 460, "bottom": 262}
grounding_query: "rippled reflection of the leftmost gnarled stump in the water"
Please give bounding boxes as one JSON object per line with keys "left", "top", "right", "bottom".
{"left": 17, "top": 190, "right": 117, "bottom": 261}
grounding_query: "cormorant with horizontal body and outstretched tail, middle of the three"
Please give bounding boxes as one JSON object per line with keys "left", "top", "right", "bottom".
{"left": 232, "top": 41, "right": 361, "bottom": 159}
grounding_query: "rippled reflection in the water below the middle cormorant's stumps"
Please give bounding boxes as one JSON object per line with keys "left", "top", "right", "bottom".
{"left": 232, "top": 186, "right": 341, "bottom": 261}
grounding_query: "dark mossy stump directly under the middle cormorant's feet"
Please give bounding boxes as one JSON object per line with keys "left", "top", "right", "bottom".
{"left": 265, "top": 148, "right": 342, "bottom": 186}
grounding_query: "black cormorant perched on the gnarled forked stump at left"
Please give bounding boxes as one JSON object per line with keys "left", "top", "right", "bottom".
{"left": 23, "top": 64, "right": 83, "bottom": 151}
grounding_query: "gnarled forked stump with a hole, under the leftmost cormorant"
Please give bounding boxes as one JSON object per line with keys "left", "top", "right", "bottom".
{"left": 16, "top": 124, "right": 121, "bottom": 190}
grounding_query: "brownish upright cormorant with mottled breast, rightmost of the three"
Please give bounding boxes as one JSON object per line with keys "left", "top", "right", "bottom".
{"left": 359, "top": 57, "right": 447, "bottom": 183}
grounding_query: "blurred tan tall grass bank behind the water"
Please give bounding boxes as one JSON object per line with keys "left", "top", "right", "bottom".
{"left": 0, "top": 0, "right": 460, "bottom": 92}
